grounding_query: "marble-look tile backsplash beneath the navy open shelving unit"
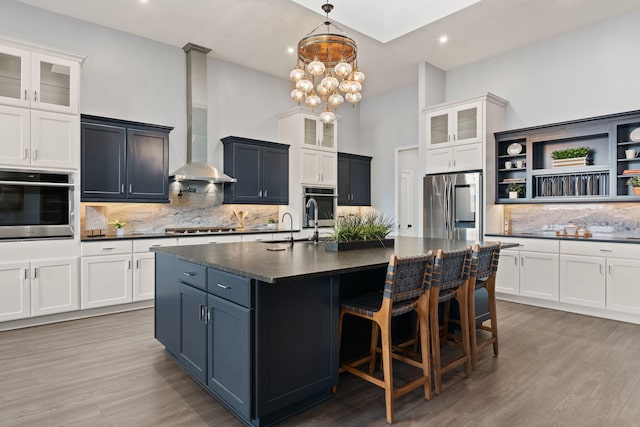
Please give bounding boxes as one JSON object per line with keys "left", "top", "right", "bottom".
{"left": 504, "top": 203, "right": 640, "bottom": 234}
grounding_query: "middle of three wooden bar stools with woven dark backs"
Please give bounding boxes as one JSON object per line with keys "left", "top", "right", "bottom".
{"left": 429, "top": 247, "right": 471, "bottom": 394}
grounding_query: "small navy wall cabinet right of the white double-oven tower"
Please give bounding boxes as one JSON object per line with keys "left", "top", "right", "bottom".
{"left": 338, "top": 153, "right": 371, "bottom": 206}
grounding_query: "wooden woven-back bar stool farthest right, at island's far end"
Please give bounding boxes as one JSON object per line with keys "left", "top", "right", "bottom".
{"left": 469, "top": 243, "right": 500, "bottom": 369}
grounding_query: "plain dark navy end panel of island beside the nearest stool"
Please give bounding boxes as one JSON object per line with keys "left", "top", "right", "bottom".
{"left": 255, "top": 277, "right": 340, "bottom": 421}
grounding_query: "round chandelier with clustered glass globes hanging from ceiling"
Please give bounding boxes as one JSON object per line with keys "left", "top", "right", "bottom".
{"left": 289, "top": 2, "right": 364, "bottom": 123}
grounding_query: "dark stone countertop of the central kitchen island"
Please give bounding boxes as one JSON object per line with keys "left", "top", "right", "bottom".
{"left": 151, "top": 237, "right": 504, "bottom": 283}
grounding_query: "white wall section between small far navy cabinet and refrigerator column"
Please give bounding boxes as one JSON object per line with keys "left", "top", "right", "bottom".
{"left": 360, "top": 83, "right": 418, "bottom": 217}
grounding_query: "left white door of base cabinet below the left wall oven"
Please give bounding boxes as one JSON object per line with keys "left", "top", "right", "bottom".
{"left": 0, "top": 262, "right": 31, "bottom": 322}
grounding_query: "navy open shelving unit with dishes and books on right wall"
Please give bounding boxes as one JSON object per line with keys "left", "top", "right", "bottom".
{"left": 495, "top": 111, "right": 640, "bottom": 204}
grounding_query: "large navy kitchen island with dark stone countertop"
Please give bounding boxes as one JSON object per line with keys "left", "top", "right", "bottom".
{"left": 152, "top": 237, "right": 500, "bottom": 426}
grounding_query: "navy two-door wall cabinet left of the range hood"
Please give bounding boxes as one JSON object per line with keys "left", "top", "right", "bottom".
{"left": 81, "top": 115, "right": 173, "bottom": 202}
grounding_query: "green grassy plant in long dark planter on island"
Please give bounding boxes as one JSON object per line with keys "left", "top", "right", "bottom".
{"left": 325, "top": 213, "right": 394, "bottom": 251}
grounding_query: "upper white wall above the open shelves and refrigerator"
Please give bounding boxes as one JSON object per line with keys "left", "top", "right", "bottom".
{"left": 446, "top": 12, "right": 640, "bottom": 130}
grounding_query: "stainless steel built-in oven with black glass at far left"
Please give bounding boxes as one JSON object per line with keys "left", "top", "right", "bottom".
{"left": 0, "top": 171, "right": 74, "bottom": 239}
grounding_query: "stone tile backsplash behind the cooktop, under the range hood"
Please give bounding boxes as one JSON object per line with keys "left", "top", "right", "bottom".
{"left": 80, "top": 185, "right": 279, "bottom": 234}
